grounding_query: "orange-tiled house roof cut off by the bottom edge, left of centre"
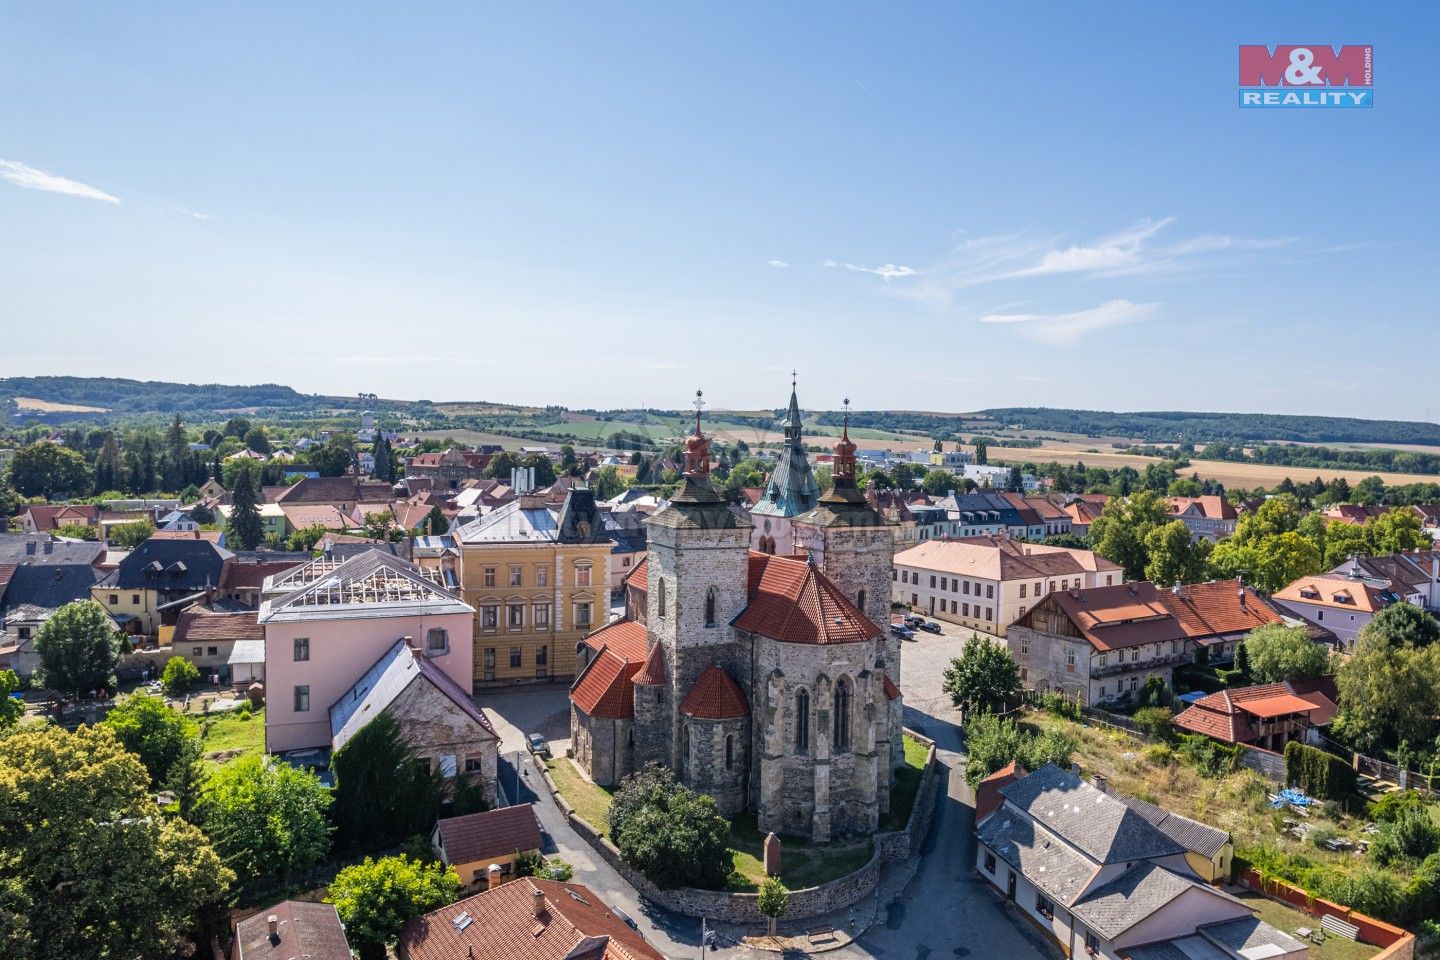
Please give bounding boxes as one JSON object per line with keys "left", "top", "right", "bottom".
{"left": 396, "top": 877, "right": 665, "bottom": 960}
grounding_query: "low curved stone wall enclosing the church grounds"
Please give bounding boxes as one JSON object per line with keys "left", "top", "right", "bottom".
{"left": 534, "top": 734, "right": 939, "bottom": 925}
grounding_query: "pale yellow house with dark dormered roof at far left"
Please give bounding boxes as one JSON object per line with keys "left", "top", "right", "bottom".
{"left": 91, "top": 537, "right": 235, "bottom": 636}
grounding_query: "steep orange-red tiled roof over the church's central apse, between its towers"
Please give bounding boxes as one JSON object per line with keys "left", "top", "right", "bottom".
{"left": 734, "top": 553, "right": 881, "bottom": 643}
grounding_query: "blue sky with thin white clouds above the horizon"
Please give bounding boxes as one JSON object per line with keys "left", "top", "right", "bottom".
{"left": 0, "top": 0, "right": 1440, "bottom": 420}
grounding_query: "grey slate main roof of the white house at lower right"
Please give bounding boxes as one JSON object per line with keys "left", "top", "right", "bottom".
{"left": 1001, "top": 763, "right": 1185, "bottom": 864}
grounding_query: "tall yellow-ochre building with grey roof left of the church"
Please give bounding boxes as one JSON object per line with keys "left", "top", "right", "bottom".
{"left": 452, "top": 488, "right": 612, "bottom": 684}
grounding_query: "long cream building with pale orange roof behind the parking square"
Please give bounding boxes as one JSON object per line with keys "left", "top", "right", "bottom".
{"left": 890, "top": 534, "right": 1125, "bottom": 636}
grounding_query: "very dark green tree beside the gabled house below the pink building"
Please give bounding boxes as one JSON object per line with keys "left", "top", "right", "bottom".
{"left": 330, "top": 714, "right": 442, "bottom": 846}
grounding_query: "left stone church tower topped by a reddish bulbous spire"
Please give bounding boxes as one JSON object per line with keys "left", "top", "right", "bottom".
{"left": 636, "top": 390, "right": 750, "bottom": 800}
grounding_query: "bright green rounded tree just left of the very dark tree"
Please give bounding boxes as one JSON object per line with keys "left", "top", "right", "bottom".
{"left": 200, "top": 756, "right": 330, "bottom": 879}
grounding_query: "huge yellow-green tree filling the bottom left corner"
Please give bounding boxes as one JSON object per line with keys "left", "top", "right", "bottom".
{"left": 0, "top": 725, "right": 235, "bottom": 960}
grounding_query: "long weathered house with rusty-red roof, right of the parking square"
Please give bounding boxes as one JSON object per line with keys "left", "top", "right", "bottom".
{"left": 1005, "top": 580, "right": 1287, "bottom": 704}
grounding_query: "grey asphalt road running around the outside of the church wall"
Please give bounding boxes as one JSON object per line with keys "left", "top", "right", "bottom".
{"left": 477, "top": 625, "right": 1058, "bottom": 960}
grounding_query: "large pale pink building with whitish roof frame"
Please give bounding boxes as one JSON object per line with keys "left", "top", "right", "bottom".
{"left": 259, "top": 550, "right": 475, "bottom": 753}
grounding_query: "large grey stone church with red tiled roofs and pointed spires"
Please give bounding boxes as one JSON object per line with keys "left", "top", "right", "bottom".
{"left": 570, "top": 394, "right": 904, "bottom": 842}
